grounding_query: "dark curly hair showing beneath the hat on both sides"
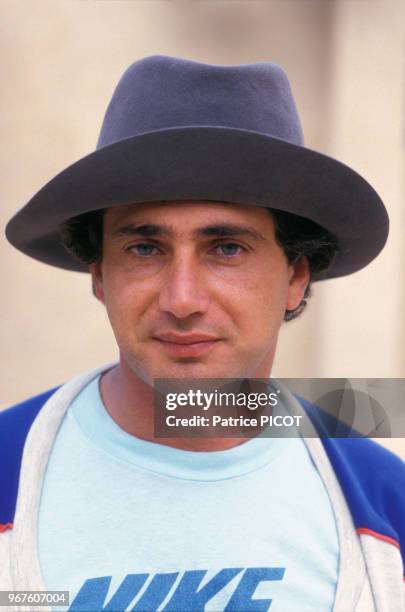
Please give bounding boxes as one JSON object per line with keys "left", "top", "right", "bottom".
{"left": 60, "top": 209, "right": 338, "bottom": 321}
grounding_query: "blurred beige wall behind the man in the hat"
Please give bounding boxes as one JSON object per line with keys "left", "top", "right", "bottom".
{"left": 0, "top": 0, "right": 405, "bottom": 454}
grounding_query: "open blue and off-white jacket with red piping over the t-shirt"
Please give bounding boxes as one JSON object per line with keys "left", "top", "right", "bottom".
{"left": 0, "top": 365, "right": 405, "bottom": 612}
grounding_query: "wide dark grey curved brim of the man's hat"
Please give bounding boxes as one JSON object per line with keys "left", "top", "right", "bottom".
{"left": 6, "top": 126, "right": 389, "bottom": 280}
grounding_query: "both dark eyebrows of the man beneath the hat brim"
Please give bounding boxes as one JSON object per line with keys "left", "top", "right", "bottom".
{"left": 113, "top": 223, "right": 265, "bottom": 240}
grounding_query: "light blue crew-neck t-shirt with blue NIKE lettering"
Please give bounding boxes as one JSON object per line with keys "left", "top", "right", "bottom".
{"left": 38, "top": 378, "right": 339, "bottom": 612}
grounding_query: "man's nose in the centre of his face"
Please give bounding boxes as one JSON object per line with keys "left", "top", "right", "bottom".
{"left": 159, "top": 254, "right": 209, "bottom": 319}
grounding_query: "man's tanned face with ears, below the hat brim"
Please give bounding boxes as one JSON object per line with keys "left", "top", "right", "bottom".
{"left": 91, "top": 201, "right": 308, "bottom": 383}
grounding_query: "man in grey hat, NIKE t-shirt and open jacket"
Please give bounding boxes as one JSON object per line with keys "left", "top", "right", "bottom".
{"left": 0, "top": 56, "right": 405, "bottom": 612}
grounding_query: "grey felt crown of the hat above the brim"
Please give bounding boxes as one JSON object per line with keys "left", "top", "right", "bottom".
{"left": 97, "top": 55, "right": 303, "bottom": 148}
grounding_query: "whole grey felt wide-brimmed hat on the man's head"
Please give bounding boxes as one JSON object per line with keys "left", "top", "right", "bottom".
{"left": 6, "top": 55, "right": 388, "bottom": 278}
